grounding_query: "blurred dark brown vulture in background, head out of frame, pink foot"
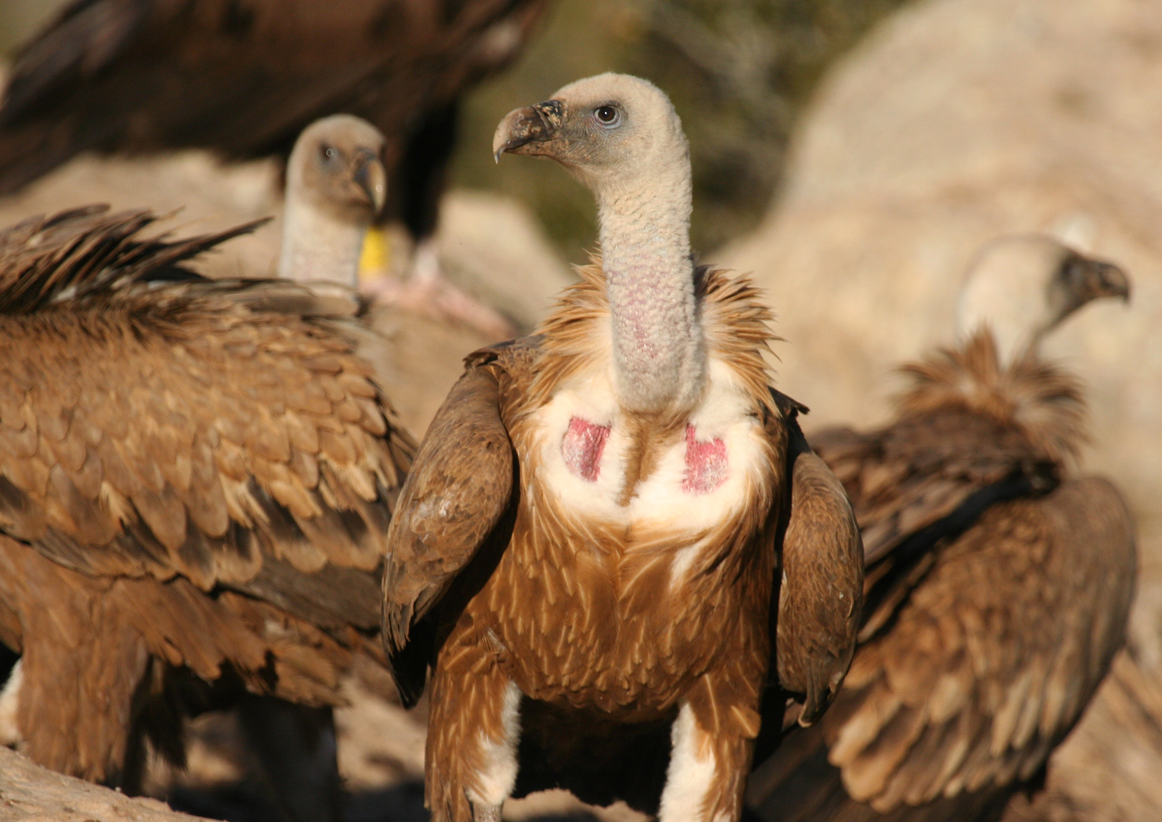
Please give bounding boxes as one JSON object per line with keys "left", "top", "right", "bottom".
{"left": 0, "top": 0, "right": 547, "bottom": 337}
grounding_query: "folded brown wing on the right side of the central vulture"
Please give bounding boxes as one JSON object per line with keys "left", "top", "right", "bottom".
{"left": 775, "top": 416, "right": 863, "bottom": 724}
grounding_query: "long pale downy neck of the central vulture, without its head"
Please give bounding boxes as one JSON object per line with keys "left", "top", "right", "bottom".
{"left": 597, "top": 168, "right": 705, "bottom": 414}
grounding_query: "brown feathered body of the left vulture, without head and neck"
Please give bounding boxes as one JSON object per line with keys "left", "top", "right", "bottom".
{"left": 0, "top": 208, "right": 414, "bottom": 804}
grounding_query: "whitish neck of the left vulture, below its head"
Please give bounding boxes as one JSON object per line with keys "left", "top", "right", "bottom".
{"left": 279, "top": 196, "right": 370, "bottom": 287}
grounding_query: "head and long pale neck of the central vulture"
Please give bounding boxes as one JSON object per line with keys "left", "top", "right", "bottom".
{"left": 493, "top": 73, "right": 705, "bottom": 413}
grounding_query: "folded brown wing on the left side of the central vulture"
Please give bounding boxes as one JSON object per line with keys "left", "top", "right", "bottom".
{"left": 383, "top": 348, "right": 516, "bottom": 705}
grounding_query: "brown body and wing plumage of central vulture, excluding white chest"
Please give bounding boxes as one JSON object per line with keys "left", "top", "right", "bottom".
{"left": 385, "top": 260, "right": 859, "bottom": 820}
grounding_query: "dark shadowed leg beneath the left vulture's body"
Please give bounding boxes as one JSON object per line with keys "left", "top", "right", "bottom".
{"left": 238, "top": 696, "right": 343, "bottom": 822}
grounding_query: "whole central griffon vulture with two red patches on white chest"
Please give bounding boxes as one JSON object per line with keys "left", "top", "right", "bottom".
{"left": 383, "top": 74, "right": 862, "bottom": 822}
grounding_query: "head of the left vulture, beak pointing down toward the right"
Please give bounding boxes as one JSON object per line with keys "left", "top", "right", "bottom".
{"left": 287, "top": 114, "right": 387, "bottom": 226}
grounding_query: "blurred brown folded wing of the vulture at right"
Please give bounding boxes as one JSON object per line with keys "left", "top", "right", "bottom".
{"left": 751, "top": 478, "right": 1136, "bottom": 821}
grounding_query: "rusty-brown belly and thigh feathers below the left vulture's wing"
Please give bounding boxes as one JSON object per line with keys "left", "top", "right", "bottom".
{"left": 0, "top": 537, "right": 374, "bottom": 780}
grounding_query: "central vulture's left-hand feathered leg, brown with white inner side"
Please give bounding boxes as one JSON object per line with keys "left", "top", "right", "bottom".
{"left": 424, "top": 641, "right": 521, "bottom": 822}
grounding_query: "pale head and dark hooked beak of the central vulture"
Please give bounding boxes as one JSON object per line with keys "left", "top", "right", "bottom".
{"left": 493, "top": 73, "right": 690, "bottom": 202}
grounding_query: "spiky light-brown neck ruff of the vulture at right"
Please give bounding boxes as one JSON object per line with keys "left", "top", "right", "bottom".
{"left": 899, "top": 330, "right": 1086, "bottom": 464}
